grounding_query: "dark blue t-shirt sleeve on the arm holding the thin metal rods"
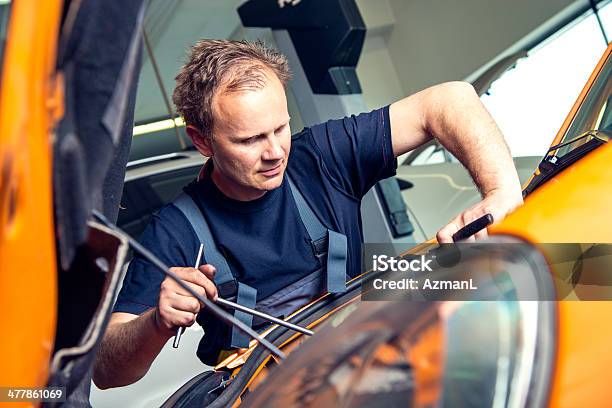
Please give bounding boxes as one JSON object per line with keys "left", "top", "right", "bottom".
{"left": 113, "top": 205, "right": 197, "bottom": 314}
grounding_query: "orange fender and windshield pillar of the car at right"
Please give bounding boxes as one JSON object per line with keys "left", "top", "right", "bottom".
{"left": 490, "top": 45, "right": 612, "bottom": 407}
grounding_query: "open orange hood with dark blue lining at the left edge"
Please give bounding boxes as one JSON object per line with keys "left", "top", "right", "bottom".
{"left": 0, "top": 0, "right": 145, "bottom": 406}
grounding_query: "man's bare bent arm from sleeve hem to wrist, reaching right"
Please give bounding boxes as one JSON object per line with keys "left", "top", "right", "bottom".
{"left": 389, "top": 81, "right": 520, "bottom": 196}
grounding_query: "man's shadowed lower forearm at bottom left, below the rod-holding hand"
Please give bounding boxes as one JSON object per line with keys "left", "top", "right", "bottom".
{"left": 93, "top": 309, "right": 172, "bottom": 389}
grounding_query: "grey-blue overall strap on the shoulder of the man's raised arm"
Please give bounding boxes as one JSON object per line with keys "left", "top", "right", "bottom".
{"left": 287, "top": 174, "right": 347, "bottom": 293}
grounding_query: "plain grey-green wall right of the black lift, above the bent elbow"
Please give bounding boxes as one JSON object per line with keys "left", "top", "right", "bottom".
{"left": 384, "top": 0, "right": 588, "bottom": 94}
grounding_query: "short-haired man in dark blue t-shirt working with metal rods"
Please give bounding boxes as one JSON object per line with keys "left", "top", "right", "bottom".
{"left": 94, "top": 40, "right": 522, "bottom": 388}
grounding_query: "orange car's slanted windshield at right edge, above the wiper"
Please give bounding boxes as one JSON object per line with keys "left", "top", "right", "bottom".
{"left": 556, "top": 51, "right": 612, "bottom": 156}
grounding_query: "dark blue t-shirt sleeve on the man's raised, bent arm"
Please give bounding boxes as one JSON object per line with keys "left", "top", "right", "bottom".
{"left": 310, "top": 106, "right": 397, "bottom": 198}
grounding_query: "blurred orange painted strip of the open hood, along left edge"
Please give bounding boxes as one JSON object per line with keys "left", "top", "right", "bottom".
{"left": 0, "top": 0, "right": 63, "bottom": 387}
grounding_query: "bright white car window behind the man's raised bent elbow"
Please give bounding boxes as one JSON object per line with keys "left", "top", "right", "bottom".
{"left": 481, "top": 3, "right": 612, "bottom": 157}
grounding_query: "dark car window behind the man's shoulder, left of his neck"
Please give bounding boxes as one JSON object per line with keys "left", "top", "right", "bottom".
{"left": 117, "top": 165, "right": 201, "bottom": 238}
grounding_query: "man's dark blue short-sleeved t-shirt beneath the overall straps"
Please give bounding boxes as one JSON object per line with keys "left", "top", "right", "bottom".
{"left": 114, "top": 107, "right": 397, "bottom": 314}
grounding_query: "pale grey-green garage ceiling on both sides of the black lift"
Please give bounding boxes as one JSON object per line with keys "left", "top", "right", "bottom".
{"left": 135, "top": 0, "right": 604, "bottom": 123}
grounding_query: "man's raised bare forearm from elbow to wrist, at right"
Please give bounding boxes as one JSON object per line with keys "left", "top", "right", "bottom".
{"left": 425, "top": 82, "right": 520, "bottom": 196}
